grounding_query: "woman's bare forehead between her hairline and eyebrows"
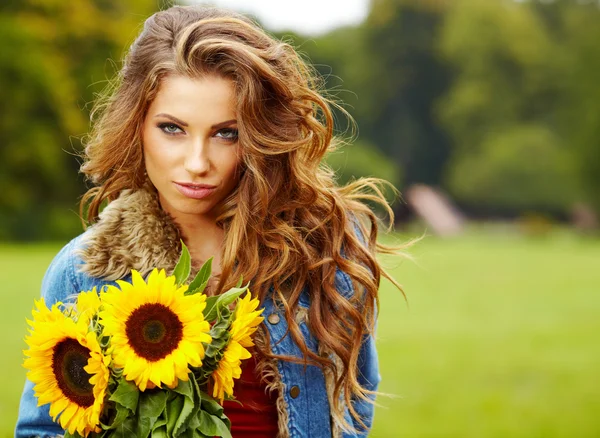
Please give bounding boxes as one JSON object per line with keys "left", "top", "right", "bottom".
{"left": 149, "top": 75, "right": 236, "bottom": 118}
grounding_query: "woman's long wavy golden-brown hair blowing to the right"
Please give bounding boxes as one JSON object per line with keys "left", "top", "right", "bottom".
{"left": 81, "top": 6, "right": 406, "bottom": 434}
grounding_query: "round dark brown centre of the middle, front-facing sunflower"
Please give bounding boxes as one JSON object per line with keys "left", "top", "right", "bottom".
{"left": 125, "top": 303, "right": 183, "bottom": 362}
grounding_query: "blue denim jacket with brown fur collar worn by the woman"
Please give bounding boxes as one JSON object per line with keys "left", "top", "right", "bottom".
{"left": 15, "top": 189, "right": 380, "bottom": 438}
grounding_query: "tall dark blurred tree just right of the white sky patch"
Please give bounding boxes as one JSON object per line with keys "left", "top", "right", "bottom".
{"left": 350, "top": 0, "right": 450, "bottom": 185}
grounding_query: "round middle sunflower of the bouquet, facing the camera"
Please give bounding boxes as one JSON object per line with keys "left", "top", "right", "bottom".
{"left": 100, "top": 269, "right": 211, "bottom": 391}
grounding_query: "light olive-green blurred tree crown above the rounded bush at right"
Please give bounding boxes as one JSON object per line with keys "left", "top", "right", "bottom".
{"left": 439, "top": 0, "right": 554, "bottom": 148}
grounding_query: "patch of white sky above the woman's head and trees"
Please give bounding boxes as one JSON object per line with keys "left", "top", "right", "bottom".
{"left": 192, "top": 0, "right": 369, "bottom": 36}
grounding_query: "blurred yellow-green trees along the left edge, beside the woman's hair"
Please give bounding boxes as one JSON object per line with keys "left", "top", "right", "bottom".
{"left": 0, "top": 0, "right": 158, "bottom": 240}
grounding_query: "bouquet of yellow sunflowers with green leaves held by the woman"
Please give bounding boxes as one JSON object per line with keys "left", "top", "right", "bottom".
{"left": 24, "top": 243, "right": 263, "bottom": 437}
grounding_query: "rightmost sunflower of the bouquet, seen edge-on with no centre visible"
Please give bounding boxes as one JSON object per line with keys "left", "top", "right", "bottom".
{"left": 212, "top": 292, "right": 264, "bottom": 403}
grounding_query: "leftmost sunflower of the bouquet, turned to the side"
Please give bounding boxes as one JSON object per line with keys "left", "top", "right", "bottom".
{"left": 23, "top": 299, "right": 110, "bottom": 437}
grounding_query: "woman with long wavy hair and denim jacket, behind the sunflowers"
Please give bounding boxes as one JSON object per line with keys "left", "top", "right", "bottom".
{"left": 16, "top": 6, "right": 408, "bottom": 437}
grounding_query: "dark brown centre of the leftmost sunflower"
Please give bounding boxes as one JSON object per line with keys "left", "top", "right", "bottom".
{"left": 52, "top": 338, "right": 94, "bottom": 408}
